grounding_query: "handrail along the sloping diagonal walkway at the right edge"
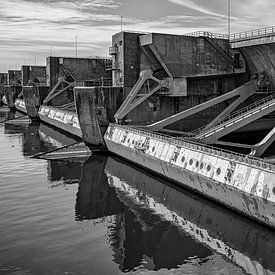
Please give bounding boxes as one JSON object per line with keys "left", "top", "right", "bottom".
{"left": 191, "top": 94, "right": 275, "bottom": 135}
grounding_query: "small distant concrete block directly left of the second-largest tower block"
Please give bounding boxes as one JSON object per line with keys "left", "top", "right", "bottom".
{"left": 21, "top": 65, "right": 46, "bottom": 86}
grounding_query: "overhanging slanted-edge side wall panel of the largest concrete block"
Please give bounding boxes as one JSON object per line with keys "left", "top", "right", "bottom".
{"left": 141, "top": 33, "right": 232, "bottom": 77}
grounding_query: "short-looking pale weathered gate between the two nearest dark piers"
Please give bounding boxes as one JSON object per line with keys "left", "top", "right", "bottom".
{"left": 38, "top": 105, "right": 82, "bottom": 138}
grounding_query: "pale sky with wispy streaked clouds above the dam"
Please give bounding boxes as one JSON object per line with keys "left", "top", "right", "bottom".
{"left": 0, "top": 0, "right": 275, "bottom": 72}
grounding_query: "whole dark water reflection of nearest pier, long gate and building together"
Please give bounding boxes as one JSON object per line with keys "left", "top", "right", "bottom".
{"left": 76, "top": 156, "right": 275, "bottom": 274}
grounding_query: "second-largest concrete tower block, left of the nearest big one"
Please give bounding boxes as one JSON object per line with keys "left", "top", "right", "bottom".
{"left": 46, "top": 56, "right": 112, "bottom": 88}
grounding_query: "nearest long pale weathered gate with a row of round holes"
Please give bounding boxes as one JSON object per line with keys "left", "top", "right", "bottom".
{"left": 104, "top": 124, "right": 275, "bottom": 228}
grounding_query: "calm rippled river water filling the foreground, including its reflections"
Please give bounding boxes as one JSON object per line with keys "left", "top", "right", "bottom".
{"left": 0, "top": 108, "right": 275, "bottom": 274}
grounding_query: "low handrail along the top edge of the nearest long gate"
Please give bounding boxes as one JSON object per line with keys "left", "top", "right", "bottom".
{"left": 109, "top": 123, "right": 275, "bottom": 172}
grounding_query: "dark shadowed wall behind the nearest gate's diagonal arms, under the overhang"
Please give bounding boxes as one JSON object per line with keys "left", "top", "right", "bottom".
{"left": 127, "top": 74, "right": 249, "bottom": 128}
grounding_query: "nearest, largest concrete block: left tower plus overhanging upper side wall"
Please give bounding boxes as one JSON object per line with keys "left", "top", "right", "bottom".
{"left": 112, "top": 32, "right": 245, "bottom": 90}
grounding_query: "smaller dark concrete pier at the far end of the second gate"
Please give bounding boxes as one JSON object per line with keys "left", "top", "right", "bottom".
{"left": 23, "top": 86, "right": 49, "bottom": 120}
